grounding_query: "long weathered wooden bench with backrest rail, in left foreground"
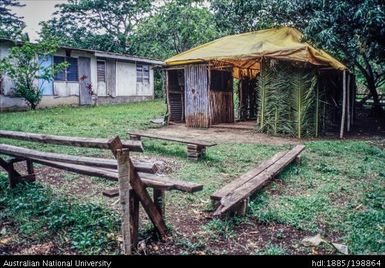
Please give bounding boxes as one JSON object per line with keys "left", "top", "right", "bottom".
{"left": 0, "top": 130, "right": 203, "bottom": 254}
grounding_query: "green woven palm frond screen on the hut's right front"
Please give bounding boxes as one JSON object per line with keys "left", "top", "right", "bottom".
{"left": 257, "top": 60, "right": 328, "bottom": 138}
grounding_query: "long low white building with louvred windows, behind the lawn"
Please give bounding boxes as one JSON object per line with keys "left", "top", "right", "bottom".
{"left": 0, "top": 39, "right": 163, "bottom": 111}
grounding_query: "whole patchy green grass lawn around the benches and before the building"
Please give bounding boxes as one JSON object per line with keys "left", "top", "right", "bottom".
{"left": 0, "top": 101, "right": 385, "bottom": 254}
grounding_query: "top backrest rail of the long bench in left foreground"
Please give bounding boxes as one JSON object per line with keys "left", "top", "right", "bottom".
{"left": 0, "top": 130, "right": 143, "bottom": 152}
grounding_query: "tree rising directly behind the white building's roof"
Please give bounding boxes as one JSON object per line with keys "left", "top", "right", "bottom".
{"left": 41, "top": 0, "right": 151, "bottom": 53}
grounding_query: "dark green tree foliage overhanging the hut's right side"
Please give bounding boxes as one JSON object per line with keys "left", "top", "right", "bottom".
{"left": 272, "top": 0, "right": 385, "bottom": 114}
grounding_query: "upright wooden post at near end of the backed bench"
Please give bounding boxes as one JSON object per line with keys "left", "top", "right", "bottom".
{"left": 116, "top": 149, "right": 132, "bottom": 255}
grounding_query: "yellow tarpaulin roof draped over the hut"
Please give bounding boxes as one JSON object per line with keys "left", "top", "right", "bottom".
{"left": 165, "top": 27, "right": 347, "bottom": 76}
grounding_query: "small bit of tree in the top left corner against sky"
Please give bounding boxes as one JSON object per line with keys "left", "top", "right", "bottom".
{"left": 0, "top": 0, "right": 25, "bottom": 39}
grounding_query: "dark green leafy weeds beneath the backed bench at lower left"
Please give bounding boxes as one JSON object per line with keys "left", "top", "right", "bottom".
{"left": 0, "top": 174, "right": 120, "bottom": 254}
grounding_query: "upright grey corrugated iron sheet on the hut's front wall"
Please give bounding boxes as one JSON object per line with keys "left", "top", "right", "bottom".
{"left": 185, "top": 64, "right": 210, "bottom": 128}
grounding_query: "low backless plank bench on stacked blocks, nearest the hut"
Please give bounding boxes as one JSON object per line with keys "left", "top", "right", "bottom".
{"left": 128, "top": 132, "right": 217, "bottom": 161}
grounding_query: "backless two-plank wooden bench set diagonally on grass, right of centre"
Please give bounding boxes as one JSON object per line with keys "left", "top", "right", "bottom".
{"left": 211, "top": 145, "right": 305, "bottom": 216}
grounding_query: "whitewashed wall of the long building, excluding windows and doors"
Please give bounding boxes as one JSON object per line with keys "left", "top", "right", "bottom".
{"left": 0, "top": 41, "right": 154, "bottom": 111}
